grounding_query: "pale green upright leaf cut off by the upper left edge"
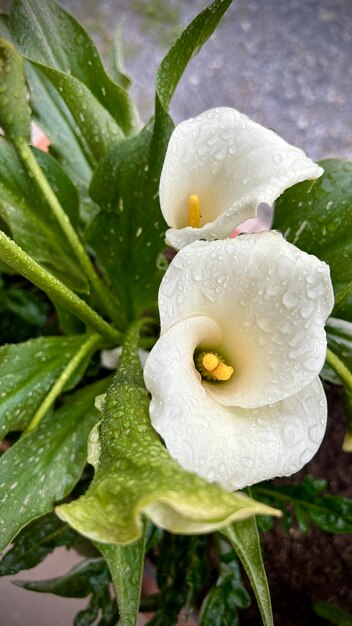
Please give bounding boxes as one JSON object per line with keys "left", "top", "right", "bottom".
{"left": 0, "top": 39, "right": 31, "bottom": 142}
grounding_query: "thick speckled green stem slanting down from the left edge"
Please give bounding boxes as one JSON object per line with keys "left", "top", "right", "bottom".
{"left": 0, "top": 231, "right": 122, "bottom": 344}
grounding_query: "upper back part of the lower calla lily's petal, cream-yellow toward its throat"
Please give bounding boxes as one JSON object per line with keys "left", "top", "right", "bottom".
{"left": 159, "top": 231, "right": 333, "bottom": 408}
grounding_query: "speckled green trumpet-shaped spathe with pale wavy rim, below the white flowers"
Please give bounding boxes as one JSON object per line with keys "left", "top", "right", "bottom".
{"left": 56, "top": 326, "right": 276, "bottom": 545}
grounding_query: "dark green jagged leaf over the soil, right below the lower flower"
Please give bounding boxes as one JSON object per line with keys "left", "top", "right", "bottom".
{"left": 252, "top": 476, "right": 352, "bottom": 533}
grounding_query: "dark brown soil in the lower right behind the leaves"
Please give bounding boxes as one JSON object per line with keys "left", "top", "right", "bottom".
{"left": 240, "top": 387, "right": 352, "bottom": 626}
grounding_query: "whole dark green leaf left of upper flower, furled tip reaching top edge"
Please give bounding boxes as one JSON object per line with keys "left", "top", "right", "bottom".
{"left": 88, "top": 0, "right": 231, "bottom": 316}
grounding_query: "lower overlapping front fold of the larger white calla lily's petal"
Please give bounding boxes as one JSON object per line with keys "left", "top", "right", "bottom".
{"left": 144, "top": 317, "right": 327, "bottom": 491}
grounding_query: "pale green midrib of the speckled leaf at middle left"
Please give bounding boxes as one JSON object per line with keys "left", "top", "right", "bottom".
{"left": 25, "top": 334, "right": 101, "bottom": 433}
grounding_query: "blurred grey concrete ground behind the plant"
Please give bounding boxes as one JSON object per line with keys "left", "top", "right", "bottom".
{"left": 0, "top": 0, "right": 352, "bottom": 626}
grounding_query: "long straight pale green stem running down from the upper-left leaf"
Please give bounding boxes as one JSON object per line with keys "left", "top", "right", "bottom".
{"left": 15, "top": 141, "right": 123, "bottom": 326}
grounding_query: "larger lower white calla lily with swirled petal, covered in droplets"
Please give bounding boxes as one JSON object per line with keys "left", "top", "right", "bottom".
{"left": 144, "top": 231, "right": 333, "bottom": 490}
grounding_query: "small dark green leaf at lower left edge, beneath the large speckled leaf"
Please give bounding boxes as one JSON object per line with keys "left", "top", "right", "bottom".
{"left": 0, "top": 515, "right": 77, "bottom": 576}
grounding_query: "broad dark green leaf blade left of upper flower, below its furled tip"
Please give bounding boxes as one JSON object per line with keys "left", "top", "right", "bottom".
{"left": 87, "top": 121, "right": 172, "bottom": 317}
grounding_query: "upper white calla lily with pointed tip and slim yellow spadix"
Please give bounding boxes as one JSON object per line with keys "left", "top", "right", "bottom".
{"left": 159, "top": 108, "right": 323, "bottom": 249}
